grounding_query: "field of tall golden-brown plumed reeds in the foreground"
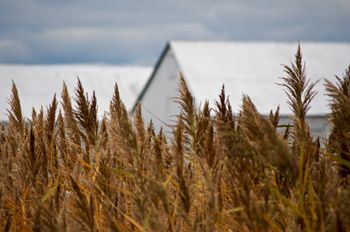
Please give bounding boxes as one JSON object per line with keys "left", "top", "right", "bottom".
{"left": 0, "top": 47, "right": 350, "bottom": 231}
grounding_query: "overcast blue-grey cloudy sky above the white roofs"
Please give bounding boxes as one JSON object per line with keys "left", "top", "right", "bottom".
{"left": 0, "top": 0, "right": 350, "bottom": 65}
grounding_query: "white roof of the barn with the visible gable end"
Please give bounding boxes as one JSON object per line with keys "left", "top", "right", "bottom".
{"left": 170, "top": 41, "right": 350, "bottom": 115}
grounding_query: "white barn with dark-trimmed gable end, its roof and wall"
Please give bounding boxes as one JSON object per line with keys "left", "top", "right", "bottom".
{"left": 138, "top": 41, "right": 350, "bottom": 137}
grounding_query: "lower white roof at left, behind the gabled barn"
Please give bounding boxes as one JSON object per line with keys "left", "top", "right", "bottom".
{"left": 0, "top": 65, "right": 152, "bottom": 120}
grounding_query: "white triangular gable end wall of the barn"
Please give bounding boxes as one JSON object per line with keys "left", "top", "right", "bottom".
{"left": 141, "top": 49, "right": 180, "bottom": 133}
